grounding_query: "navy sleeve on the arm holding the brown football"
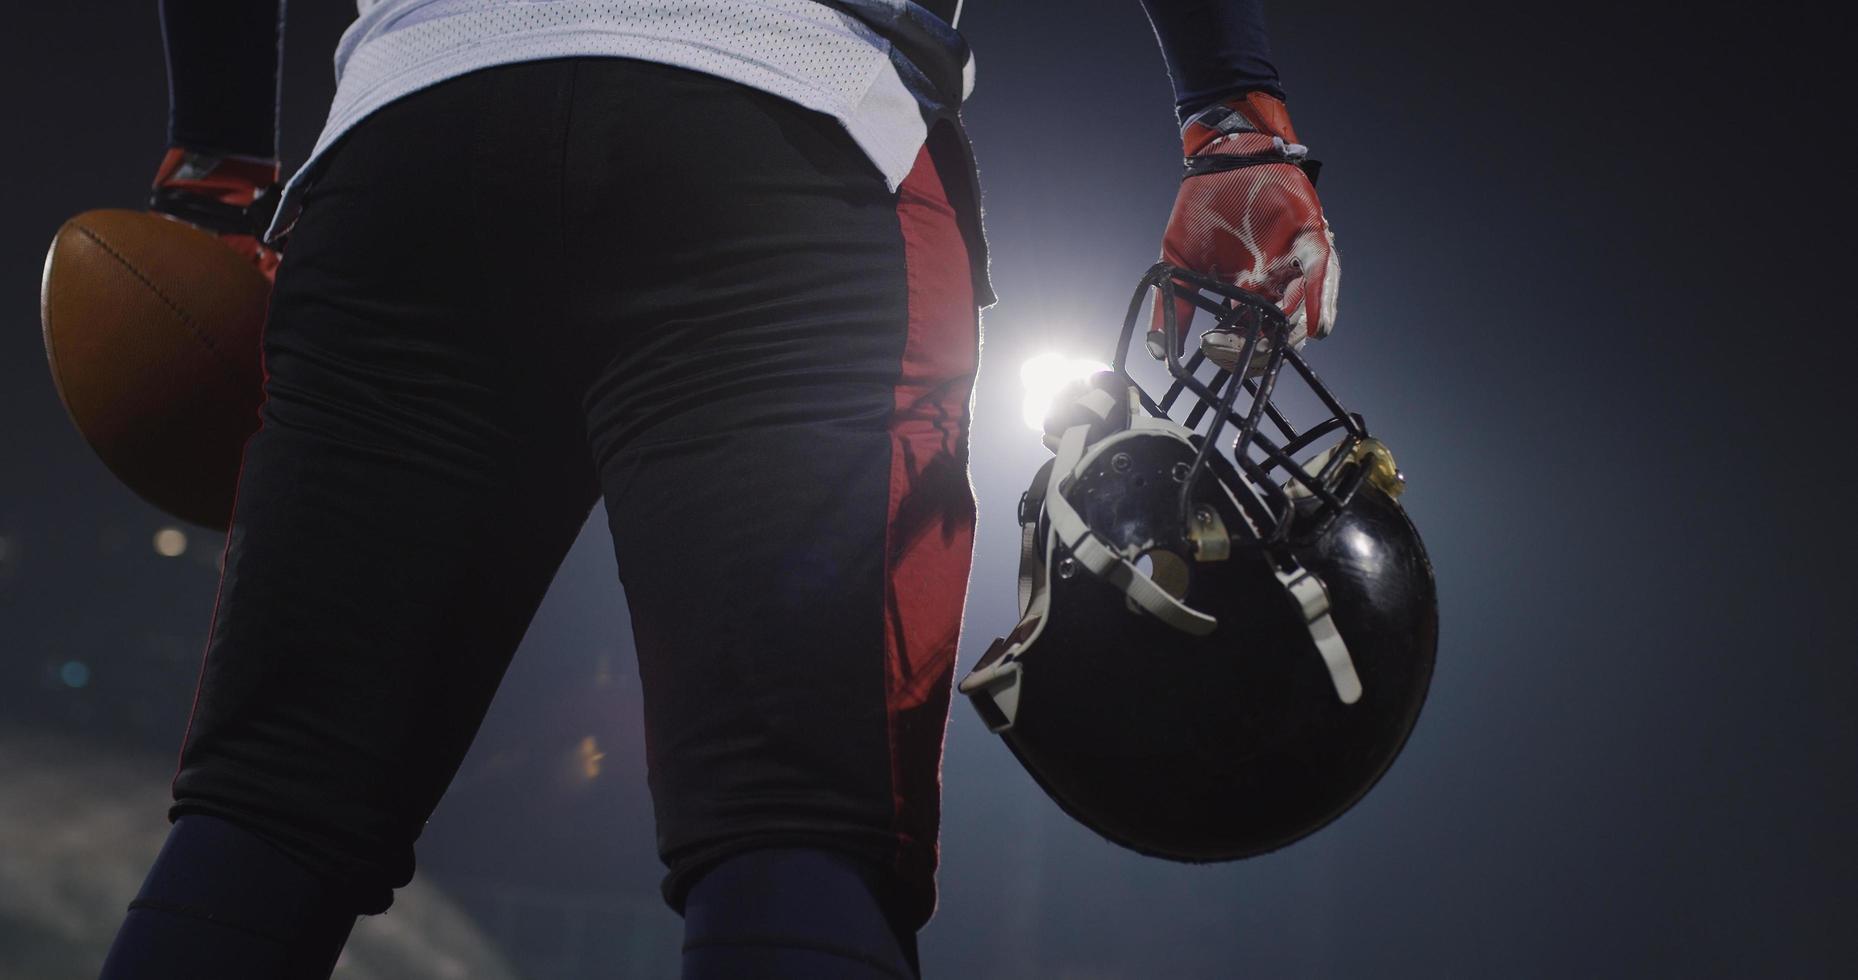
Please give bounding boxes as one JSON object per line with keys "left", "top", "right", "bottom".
{"left": 160, "top": 0, "right": 284, "bottom": 160}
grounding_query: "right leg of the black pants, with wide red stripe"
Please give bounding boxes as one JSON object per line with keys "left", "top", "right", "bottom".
{"left": 570, "top": 57, "right": 977, "bottom": 933}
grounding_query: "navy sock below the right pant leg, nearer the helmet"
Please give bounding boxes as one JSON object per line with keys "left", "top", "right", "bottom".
{"left": 684, "top": 848, "right": 916, "bottom": 980}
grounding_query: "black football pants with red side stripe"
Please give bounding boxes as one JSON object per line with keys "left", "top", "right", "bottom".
{"left": 173, "top": 60, "right": 977, "bottom": 937}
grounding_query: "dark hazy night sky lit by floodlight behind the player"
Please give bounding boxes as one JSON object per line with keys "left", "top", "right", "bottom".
{"left": 0, "top": 0, "right": 1858, "bottom": 978}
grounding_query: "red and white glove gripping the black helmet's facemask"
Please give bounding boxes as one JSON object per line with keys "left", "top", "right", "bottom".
{"left": 1148, "top": 91, "right": 1341, "bottom": 368}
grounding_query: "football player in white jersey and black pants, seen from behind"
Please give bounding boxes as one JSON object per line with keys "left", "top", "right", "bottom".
{"left": 104, "top": 0, "right": 1338, "bottom": 980}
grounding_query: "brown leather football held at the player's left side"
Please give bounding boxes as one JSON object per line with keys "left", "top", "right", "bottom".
{"left": 39, "top": 210, "right": 271, "bottom": 530}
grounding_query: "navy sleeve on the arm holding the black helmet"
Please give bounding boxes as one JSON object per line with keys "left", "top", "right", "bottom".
{"left": 1143, "top": 0, "right": 1284, "bottom": 123}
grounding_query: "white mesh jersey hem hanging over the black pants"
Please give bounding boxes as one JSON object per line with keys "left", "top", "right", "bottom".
{"left": 268, "top": 0, "right": 974, "bottom": 238}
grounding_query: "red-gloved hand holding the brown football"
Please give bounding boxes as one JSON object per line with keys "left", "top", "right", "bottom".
{"left": 149, "top": 147, "right": 279, "bottom": 279}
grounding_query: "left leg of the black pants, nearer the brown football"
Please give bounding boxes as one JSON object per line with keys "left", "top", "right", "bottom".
{"left": 175, "top": 59, "right": 596, "bottom": 911}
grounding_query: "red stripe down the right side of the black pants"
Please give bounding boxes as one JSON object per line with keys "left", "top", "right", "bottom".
{"left": 884, "top": 137, "right": 979, "bottom": 903}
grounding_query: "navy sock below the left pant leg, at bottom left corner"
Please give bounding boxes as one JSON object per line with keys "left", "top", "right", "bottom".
{"left": 98, "top": 814, "right": 355, "bottom": 980}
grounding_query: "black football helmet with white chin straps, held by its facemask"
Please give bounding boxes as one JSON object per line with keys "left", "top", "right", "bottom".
{"left": 961, "top": 264, "right": 1438, "bottom": 861}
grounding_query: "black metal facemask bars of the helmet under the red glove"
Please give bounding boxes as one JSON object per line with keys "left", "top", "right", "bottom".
{"left": 1111, "top": 262, "right": 1367, "bottom": 547}
